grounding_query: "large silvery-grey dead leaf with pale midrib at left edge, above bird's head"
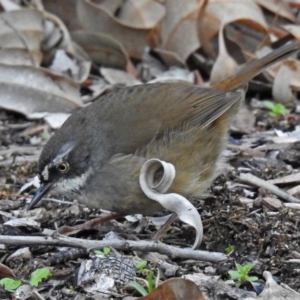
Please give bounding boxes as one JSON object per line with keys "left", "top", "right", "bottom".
{"left": 0, "top": 64, "right": 82, "bottom": 117}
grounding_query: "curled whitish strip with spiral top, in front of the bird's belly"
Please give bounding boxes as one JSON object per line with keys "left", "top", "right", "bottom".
{"left": 140, "top": 158, "right": 203, "bottom": 249}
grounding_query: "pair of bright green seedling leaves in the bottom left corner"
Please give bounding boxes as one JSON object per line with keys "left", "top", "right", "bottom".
{"left": 0, "top": 268, "right": 52, "bottom": 292}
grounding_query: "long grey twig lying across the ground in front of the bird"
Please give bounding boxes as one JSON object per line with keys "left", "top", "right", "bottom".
{"left": 0, "top": 234, "right": 227, "bottom": 262}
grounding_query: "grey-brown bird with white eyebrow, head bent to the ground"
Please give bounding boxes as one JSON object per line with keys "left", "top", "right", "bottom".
{"left": 28, "top": 42, "right": 299, "bottom": 215}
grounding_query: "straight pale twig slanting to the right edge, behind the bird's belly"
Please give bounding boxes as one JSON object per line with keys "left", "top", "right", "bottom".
{"left": 240, "top": 173, "right": 300, "bottom": 203}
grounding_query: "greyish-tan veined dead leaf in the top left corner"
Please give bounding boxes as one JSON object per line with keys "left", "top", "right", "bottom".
{"left": 0, "top": 9, "right": 43, "bottom": 66}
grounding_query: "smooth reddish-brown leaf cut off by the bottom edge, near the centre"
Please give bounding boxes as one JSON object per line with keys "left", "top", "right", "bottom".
{"left": 138, "top": 278, "right": 204, "bottom": 300}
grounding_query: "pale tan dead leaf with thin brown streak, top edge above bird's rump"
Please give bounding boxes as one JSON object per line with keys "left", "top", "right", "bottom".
{"left": 161, "top": 0, "right": 204, "bottom": 61}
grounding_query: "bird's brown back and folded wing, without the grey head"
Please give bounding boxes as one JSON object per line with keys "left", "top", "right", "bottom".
{"left": 82, "top": 82, "right": 244, "bottom": 154}
